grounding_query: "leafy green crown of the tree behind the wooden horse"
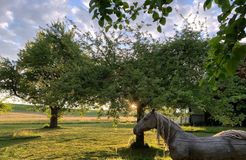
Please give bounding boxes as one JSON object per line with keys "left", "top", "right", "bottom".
{"left": 81, "top": 21, "right": 208, "bottom": 122}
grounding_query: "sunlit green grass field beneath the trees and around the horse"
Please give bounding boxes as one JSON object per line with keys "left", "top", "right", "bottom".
{"left": 0, "top": 104, "right": 246, "bottom": 160}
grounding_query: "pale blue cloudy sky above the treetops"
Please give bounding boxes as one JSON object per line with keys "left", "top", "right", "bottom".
{"left": 0, "top": 0, "right": 223, "bottom": 60}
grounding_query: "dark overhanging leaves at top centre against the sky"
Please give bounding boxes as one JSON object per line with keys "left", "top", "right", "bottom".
{"left": 89, "top": 0, "right": 173, "bottom": 32}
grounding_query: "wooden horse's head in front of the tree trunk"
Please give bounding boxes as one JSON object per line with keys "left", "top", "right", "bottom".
{"left": 133, "top": 109, "right": 157, "bottom": 135}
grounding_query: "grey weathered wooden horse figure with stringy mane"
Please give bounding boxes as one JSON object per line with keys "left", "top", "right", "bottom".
{"left": 133, "top": 110, "right": 246, "bottom": 160}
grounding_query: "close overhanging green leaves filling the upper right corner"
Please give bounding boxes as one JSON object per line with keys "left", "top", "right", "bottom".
{"left": 204, "top": 0, "right": 246, "bottom": 84}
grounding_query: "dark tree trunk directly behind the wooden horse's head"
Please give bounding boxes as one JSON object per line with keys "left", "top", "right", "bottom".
{"left": 136, "top": 104, "right": 144, "bottom": 147}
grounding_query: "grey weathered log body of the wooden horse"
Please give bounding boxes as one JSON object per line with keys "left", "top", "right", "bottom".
{"left": 170, "top": 137, "right": 246, "bottom": 160}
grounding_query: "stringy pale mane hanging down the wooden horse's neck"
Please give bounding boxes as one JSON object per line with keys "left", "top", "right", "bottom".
{"left": 155, "top": 112, "right": 182, "bottom": 143}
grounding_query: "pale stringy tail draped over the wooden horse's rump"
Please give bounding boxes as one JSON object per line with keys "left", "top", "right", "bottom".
{"left": 214, "top": 130, "right": 246, "bottom": 140}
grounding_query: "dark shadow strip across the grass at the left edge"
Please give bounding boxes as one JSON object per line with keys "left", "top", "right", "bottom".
{"left": 0, "top": 135, "right": 41, "bottom": 148}
